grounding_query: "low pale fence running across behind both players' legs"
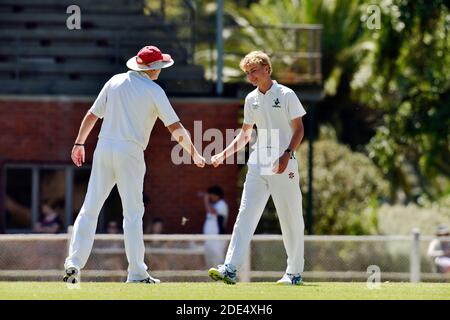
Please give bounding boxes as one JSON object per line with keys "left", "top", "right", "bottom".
{"left": 0, "top": 232, "right": 450, "bottom": 282}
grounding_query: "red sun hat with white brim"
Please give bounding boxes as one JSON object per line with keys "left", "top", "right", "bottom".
{"left": 127, "top": 46, "right": 174, "bottom": 71}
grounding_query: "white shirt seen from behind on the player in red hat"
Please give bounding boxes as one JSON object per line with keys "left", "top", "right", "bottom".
{"left": 89, "top": 71, "right": 180, "bottom": 150}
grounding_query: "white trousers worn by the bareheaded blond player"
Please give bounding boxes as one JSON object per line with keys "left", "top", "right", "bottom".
{"left": 225, "top": 151, "right": 305, "bottom": 273}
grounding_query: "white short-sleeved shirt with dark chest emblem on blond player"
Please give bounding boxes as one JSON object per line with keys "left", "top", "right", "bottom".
{"left": 244, "top": 81, "right": 306, "bottom": 152}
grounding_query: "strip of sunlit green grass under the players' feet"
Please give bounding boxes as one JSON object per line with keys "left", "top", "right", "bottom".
{"left": 0, "top": 282, "right": 450, "bottom": 300}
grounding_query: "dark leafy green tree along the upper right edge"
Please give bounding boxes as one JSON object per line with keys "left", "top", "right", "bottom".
{"left": 352, "top": 0, "right": 450, "bottom": 202}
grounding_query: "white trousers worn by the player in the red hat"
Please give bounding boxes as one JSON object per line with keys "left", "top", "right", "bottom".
{"left": 64, "top": 138, "right": 149, "bottom": 281}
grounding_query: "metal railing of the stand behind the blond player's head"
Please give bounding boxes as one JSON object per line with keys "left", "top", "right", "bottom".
{"left": 196, "top": 23, "right": 323, "bottom": 85}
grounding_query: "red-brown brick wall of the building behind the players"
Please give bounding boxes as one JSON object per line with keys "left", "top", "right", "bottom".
{"left": 0, "top": 97, "right": 240, "bottom": 233}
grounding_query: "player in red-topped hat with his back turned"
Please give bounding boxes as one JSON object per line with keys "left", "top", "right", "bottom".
{"left": 63, "top": 46, "right": 205, "bottom": 283}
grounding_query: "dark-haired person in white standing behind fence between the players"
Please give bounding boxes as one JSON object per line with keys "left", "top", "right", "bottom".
{"left": 202, "top": 186, "right": 228, "bottom": 265}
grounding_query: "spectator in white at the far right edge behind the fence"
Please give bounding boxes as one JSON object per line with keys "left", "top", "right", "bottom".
{"left": 428, "top": 225, "right": 450, "bottom": 273}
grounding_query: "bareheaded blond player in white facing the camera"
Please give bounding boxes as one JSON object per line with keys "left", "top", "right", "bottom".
{"left": 208, "top": 51, "right": 306, "bottom": 285}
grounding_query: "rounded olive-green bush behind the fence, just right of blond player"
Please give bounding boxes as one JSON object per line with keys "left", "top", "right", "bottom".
{"left": 298, "top": 129, "right": 387, "bottom": 235}
